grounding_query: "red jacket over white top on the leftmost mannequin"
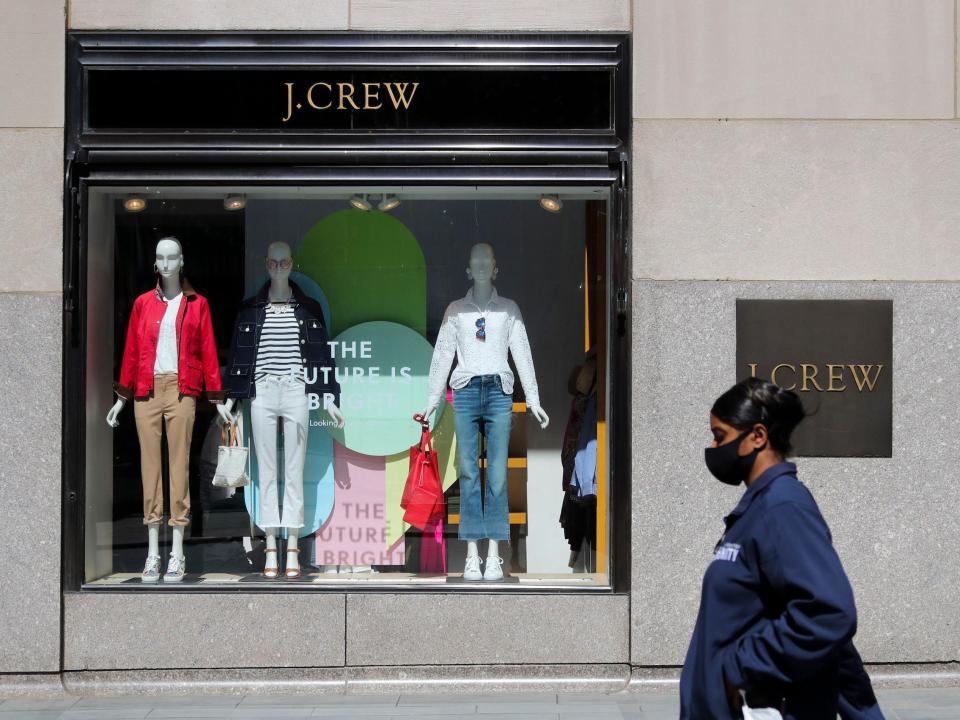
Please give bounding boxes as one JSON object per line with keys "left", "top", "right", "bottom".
{"left": 113, "top": 285, "right": 226, "bottom": 402}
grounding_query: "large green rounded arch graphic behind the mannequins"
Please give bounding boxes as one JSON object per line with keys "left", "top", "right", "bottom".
{"left": 295, "top": 208, "right": 427, "bottom": 336}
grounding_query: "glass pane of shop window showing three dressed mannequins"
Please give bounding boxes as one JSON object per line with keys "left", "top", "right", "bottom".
{"left": 85, "top": 186, "right": 609, "bottom": 589}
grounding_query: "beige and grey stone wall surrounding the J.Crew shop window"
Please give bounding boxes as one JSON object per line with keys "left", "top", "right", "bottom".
{"left": 0, "top": 0, "right": 960, "bottom": 689}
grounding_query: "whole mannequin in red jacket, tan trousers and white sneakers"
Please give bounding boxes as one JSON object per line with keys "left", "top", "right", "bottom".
{"left": 107, "top": 237, "right": 230, "bottom": 583}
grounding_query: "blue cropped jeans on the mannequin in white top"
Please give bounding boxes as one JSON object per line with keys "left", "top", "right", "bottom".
{"left": 453, "top": 375, "right": 513, "bottom": 540}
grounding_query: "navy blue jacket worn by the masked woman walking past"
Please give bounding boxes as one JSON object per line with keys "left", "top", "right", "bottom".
{"left": 680, "top": 463, "right": 859, "bottom": 720}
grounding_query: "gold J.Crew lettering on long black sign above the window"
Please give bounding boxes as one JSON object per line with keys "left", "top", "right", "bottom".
{"left": 283, "top": 82, "right": 420, "bottom": 122}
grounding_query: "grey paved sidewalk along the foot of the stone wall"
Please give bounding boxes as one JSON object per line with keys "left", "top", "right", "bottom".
{"left": 0, "top": 688, "right": 960, "bottom": 720}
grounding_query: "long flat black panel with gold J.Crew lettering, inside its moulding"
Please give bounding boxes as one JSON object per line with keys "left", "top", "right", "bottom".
{"left": 86, "top": 67, "right": 613, "bottom": 132}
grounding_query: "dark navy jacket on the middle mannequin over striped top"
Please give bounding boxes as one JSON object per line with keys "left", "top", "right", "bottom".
{"left": 223, "top": 282, "right": 340, "bottom": 405}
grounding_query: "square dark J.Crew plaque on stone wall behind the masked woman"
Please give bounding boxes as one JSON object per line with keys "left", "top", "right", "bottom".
{"left": 737, "top": 300, "right": 893, "bottom": 457}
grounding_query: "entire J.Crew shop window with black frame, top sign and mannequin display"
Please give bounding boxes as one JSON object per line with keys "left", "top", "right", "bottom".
{"left": 63, "top": 32, "right": 632, "bottom": 594}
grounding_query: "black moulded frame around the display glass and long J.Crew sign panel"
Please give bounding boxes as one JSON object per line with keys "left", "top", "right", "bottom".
{"left": 62, "top": 33, "right": 632, "bottom": 595}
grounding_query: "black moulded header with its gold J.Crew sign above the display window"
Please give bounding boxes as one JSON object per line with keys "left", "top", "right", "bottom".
{"left": 66, "top": 32, "right": 631, "bottom": 165}
